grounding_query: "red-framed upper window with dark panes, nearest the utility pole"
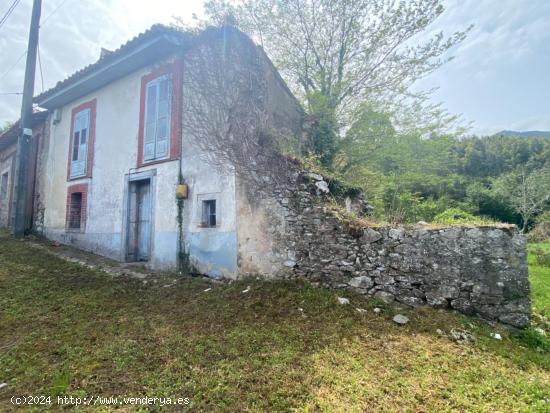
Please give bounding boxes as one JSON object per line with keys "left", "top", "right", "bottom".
{"left": 67, "top": 99, "right": 97, "bottom": 181}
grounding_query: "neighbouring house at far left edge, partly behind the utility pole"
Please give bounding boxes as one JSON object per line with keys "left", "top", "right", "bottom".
{"left": 0, "top": 111, "right": 48, "bottom": 228}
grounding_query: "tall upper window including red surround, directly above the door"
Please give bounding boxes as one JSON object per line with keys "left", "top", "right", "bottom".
{"left": 137, "top": 60, "right": 182, "bottom": 167}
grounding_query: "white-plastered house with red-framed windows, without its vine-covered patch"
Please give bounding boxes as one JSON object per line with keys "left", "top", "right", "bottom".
{"left": 30, "top": 25, "right": 302, "bottom": 277}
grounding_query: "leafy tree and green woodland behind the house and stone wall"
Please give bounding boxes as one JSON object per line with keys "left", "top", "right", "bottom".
{"left": 187, "top": 0, "right": 550, "bottom": 227}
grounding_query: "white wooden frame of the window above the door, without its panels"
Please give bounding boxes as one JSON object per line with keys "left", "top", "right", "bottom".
{"left": 142, "top": 73, "right": 173, "bottom": 164}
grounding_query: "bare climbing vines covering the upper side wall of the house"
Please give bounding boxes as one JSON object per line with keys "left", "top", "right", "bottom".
{"left": 183, "top": 25, "right": 296, "bottom": 191}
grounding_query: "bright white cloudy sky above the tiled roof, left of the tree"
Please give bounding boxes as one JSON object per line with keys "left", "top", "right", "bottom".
{"left": 0, "top": 0, "right": 202, "bottom": 125}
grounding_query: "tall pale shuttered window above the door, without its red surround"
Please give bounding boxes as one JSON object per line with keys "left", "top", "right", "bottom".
{"left": 143, "top": 75, "right": 172, "bottom": 162}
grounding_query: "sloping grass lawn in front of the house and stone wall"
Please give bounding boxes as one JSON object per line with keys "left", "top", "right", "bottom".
{"left": 0, "top": 235, "right": 550, "bottom": 412}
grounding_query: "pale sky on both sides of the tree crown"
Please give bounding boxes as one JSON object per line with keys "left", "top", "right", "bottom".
{"left": 0, "top": 0, "right": 550, "bottom": 134}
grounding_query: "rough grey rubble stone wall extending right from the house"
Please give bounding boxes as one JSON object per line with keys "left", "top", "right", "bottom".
{"left": 240, "top": 169, "right": 530, "bottom": 327}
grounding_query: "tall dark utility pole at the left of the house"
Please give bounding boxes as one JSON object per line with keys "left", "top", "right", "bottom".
{"left": 12, "top": 0, "right": 42, "bottom": 238}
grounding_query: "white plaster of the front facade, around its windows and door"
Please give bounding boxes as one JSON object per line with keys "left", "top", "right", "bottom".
{"left": 38, "top": 56, "right": 183, "bottom": 269}
